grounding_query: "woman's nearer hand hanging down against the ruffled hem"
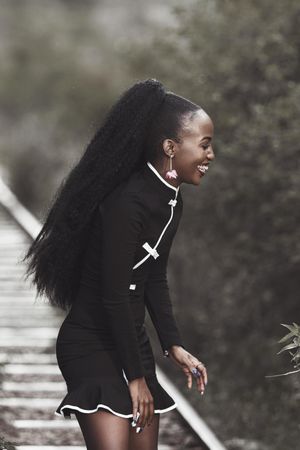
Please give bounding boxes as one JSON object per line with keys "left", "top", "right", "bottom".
{"left": 128, "top": 377, "right": 154, "bottom": 428}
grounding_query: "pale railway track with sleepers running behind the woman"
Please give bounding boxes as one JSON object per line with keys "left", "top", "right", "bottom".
{"left": 0, "top": 178, "right": 226, "bottom": 450}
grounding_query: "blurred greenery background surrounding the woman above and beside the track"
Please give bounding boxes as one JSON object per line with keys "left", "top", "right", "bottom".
{"left": 0, "top": 0, "right": 300, "bottom": 450}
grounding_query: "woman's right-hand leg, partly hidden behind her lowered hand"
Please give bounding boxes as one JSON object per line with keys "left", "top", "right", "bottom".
{"left": 129, "top": 413, "right": 160, "bottom": 450}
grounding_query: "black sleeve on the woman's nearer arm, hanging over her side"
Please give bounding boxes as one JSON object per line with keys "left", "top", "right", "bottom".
{"left": 101, "top": 193, "right": 146, "bottom": 381}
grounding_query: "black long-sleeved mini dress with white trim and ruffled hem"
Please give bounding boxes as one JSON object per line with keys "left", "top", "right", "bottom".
{"left": 55, "top": 161, "right": 184, "bottom": 418}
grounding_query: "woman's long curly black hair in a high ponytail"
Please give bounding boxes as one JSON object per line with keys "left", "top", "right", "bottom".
{"left": 22, "top": 78, "right": 201, "bottom": 310}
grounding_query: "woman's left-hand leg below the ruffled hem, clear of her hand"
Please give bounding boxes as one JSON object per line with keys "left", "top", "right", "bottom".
{"left": 75, "top": 409, "right": 129, "bottom": 450}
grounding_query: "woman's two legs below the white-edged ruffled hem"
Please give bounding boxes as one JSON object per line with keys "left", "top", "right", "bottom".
{"left": 75, "top": 409, "right": 159, "bottom": 450}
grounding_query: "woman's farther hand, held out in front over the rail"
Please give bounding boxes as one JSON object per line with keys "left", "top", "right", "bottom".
{"left": 169, "top": 345, "right": 208, "bottom": 395}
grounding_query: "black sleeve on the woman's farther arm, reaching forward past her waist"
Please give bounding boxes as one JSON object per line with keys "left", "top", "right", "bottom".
{"left": 145, "top": 244, "right": 185, "bottom": 356}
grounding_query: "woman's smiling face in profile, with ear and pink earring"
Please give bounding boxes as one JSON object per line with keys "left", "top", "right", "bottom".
{"left": 163, "top": 109, "right": 215, "bottom": 186}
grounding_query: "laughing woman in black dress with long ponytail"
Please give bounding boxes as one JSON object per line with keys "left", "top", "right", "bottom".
{"left": 25, "top": 79, "right": 214, "bottom": 450}
